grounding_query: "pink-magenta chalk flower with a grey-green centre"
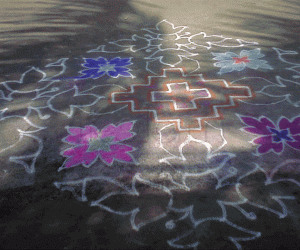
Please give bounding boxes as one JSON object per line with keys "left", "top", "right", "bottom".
{"left": 58, "top": 122, "right": 135, "bottom": 171}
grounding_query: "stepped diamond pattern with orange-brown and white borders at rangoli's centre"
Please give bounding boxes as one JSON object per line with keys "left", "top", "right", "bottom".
{"left": 110, "top": 68, "right": 254, "bottom": 131}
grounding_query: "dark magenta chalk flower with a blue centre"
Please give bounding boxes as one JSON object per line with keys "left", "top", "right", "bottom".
{"left": 240, "top": 116, "right": 300, "bottom": 154}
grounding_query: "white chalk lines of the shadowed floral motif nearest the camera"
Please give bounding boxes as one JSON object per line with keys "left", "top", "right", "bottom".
{"left": 54, "top": 159, "right": 300, "bottom": 250}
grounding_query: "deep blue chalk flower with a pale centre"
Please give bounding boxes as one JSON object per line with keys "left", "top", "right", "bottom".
{"left": 76, "top": 57, "right": 133, "bottom": 79}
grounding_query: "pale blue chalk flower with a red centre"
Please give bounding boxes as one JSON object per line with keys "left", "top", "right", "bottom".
{"left": 212, "top": 49, "right": 273, "bottom": 75}
